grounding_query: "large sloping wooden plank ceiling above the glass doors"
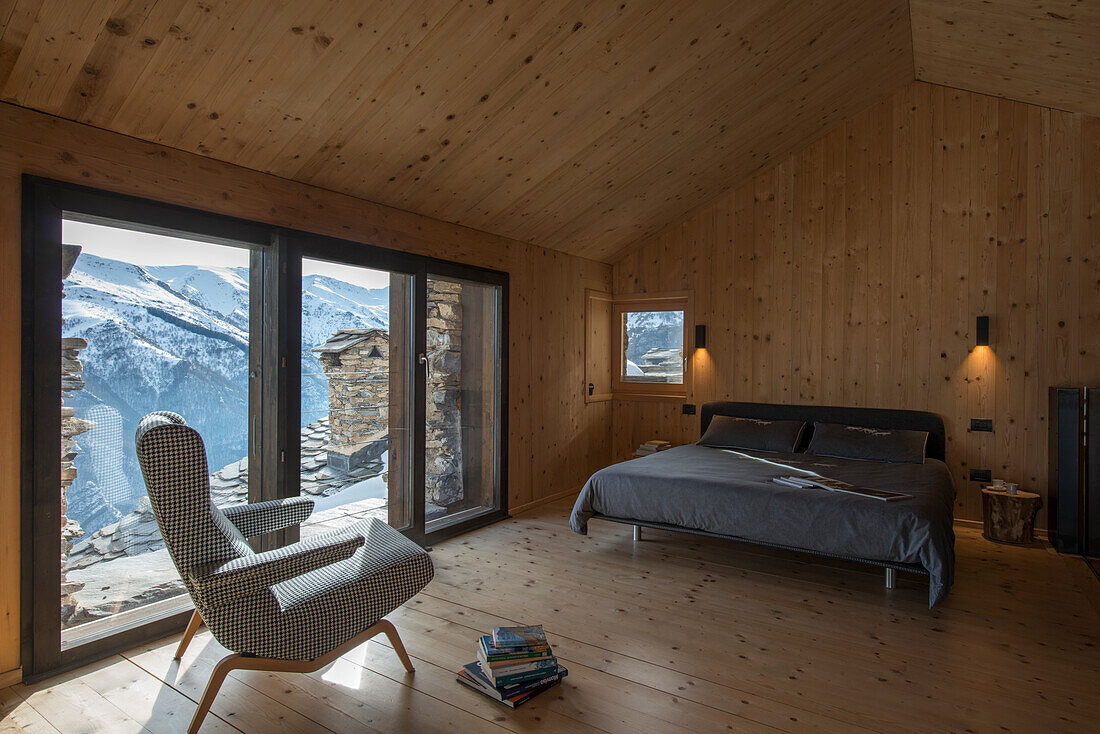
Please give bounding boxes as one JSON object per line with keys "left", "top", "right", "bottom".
{"left": 0, "top": 0, "right": 913, "bottom": 260}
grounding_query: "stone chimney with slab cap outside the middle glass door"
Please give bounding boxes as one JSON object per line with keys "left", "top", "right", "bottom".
{"left": 312, "top": 329, "right": 389, "bottom": 472}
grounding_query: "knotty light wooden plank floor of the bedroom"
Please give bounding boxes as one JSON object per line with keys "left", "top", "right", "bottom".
{"left": 0, "top": 502, "right": 1100, "bottom": 734}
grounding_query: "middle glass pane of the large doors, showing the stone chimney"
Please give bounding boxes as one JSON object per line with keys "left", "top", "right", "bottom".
{"left": 299, "top": 258, "right": 414, "bottom": 538}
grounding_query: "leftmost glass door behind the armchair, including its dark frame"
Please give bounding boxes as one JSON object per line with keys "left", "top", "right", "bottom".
{"left": 20, "top": 177, "right": 274, "bottom": 677}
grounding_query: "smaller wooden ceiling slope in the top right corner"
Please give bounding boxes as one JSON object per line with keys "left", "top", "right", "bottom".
{"left": 910, "top": 0, "right": 1100, "bottom": 116}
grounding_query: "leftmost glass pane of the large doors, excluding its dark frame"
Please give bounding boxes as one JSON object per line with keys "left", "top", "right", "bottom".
{"left": 58, "top": 216, "right": 258, "bottom": 650}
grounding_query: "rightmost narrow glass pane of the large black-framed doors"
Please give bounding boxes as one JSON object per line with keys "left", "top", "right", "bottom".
{"left": 424, "top": 275, "right": 502, "bottom": 535}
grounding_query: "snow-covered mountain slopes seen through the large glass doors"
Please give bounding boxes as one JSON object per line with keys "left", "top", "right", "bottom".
{"left": 62, "top": 253, "right": 389, "bottom": 533}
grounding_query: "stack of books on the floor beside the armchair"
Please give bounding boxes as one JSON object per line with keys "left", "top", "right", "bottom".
{"left": 457, "top": 625, "right": 569, "bottom": 709}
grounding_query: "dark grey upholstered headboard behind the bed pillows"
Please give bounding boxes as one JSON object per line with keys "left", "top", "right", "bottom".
{"left": 700, "top": 401, "right": 947, "bottom": 461}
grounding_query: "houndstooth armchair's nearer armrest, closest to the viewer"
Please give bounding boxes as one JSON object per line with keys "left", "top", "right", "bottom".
{"left": 188, "top": 533, "right": 364, "bottom": 609}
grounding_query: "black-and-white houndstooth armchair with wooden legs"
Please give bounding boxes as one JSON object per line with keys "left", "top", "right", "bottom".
{"left": 135, "top": 412, "right": 433, "bottom": 732}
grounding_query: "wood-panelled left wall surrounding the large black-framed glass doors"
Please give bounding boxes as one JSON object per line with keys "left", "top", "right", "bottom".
{"left": 0, "top": 103, "right": 611, "bottom": 684}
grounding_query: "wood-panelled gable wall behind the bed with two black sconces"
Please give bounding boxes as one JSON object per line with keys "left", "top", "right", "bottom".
{"left": 613, "top": 83, "right": 1100, "bottom": 519}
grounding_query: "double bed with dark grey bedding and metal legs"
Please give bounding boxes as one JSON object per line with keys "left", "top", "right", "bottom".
{"left": 570, "top": 402, "right": 955, "bottom": 606}
